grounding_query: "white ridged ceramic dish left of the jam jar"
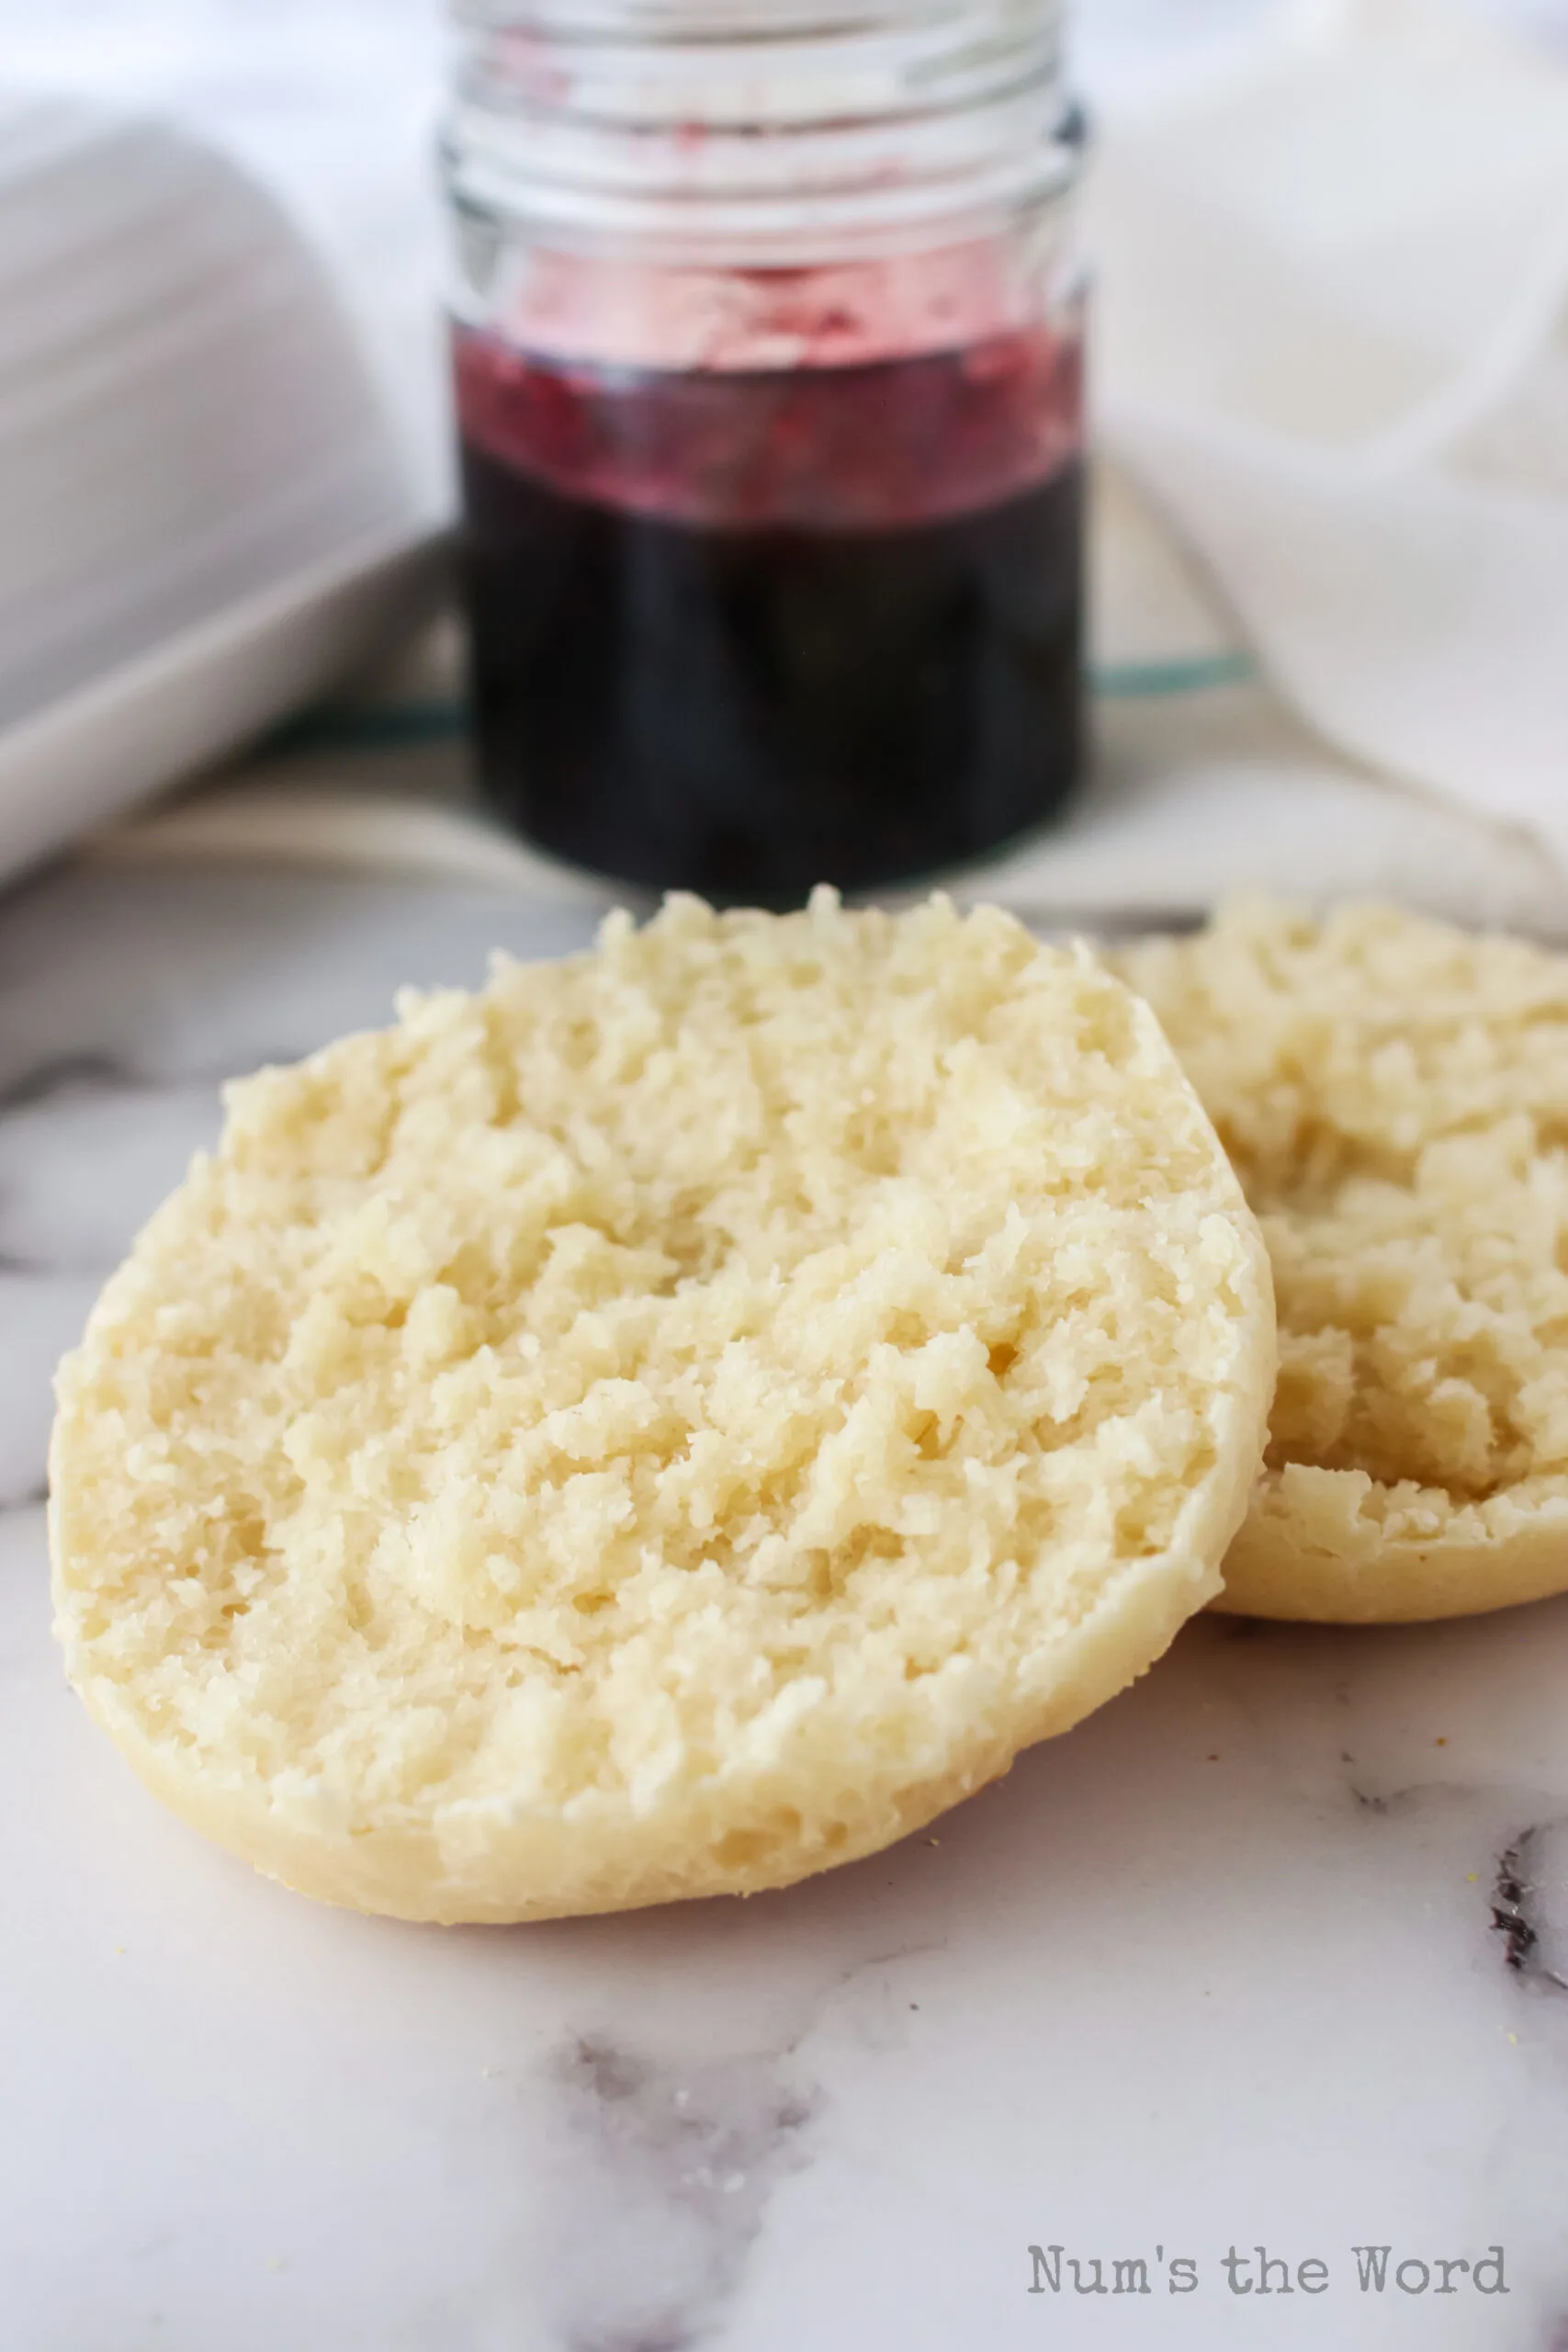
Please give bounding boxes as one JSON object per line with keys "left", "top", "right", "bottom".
{"left": 0, "top": 99, "right": 440, "bottom": 877}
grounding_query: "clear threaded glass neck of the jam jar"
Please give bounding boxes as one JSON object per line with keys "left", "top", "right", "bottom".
{"left": 445, "top": 0, "right": 1077, "bottom": 268}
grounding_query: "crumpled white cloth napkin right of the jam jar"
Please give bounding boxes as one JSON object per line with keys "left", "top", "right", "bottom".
{"left": 1090, "top": 0, "right": 1568, "bottom": 864}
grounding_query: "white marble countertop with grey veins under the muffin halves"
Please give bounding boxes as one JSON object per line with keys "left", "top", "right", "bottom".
{"left": 0, "top": 865, "right": 1568, "bottom": 2352}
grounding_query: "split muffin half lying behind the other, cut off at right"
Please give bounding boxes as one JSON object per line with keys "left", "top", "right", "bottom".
{"left": 1119, "top": 900, "right": 1568, "bottom": 1621}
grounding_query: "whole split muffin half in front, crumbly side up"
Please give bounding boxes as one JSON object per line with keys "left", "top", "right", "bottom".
{"left": 51, "top": 891, "right": 1274, "bottom": 1919}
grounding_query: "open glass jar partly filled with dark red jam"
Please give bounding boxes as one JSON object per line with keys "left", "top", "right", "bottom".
{"left": 446, "top": 0, "right": 1084, "bottom": 906}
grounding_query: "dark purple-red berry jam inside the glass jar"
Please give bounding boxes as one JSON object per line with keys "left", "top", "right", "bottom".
{"left": 458, "top": 312, "right": 1081, "bottom": 906}
